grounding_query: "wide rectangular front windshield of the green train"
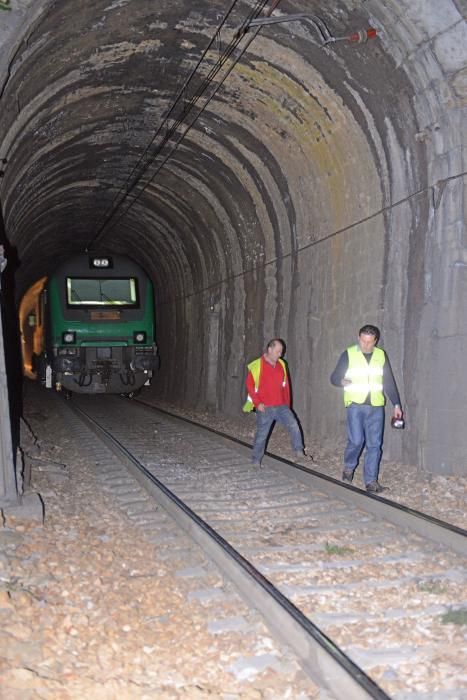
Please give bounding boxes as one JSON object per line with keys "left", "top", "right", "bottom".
{"left": 66, "top": 277, "right": 138, "bottom": 307}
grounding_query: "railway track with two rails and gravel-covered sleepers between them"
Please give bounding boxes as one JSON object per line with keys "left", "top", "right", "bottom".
{"left": 68, "top": 396, "right": 467, "bottom": 700}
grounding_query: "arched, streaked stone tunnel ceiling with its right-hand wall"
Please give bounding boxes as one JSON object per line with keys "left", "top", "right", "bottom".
{"left": 0, "top": 0, "right": 467, "bottom": 473}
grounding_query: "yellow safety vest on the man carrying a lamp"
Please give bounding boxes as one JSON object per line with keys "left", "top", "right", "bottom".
{"left": 344, "top": 345, "right": 386, "bottom": 406}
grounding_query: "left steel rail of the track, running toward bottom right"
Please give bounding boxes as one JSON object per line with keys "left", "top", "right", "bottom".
{"left": 67, "top": 402, "right": 390, "bottom": 700}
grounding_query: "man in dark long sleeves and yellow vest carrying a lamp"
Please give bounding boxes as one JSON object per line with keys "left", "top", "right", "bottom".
{"left": 331, "top": 324, "right": 403, "bottom": 493}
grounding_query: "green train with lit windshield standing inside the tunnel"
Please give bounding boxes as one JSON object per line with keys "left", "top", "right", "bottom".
{"left": 33, "top": 254, "right": 159, "bottom": 395}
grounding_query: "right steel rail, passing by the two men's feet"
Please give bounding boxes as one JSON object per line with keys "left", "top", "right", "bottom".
{"left": 133, "top": 399, "right": 467, "bottom": 556}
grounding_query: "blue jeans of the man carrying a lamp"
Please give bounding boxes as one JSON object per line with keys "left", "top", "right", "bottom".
{"left": 344, "top": 403, "right": 384, "bottom": 485}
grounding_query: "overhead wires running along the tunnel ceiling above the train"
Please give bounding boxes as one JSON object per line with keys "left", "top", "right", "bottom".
{"left": 86, "top": 0, "right": 280, "bottom": 251}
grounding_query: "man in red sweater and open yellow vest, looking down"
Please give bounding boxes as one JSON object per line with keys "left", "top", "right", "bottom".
{"left": 243, "top": 338, "right": 306, "bottom": 466}
